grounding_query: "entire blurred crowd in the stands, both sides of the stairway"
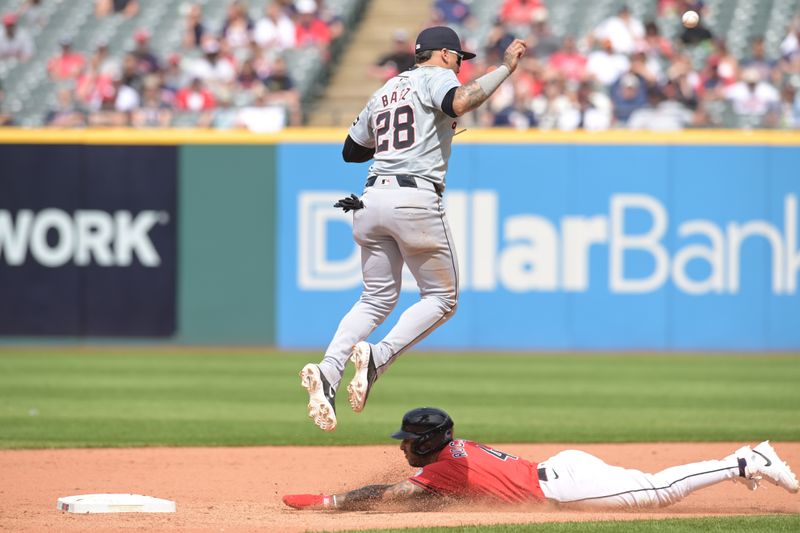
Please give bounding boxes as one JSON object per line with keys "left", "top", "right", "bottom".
{"left": 0, "top": 0, "right": 800, "bottom": 130}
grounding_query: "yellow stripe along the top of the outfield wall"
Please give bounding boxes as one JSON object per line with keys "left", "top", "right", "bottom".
{"left": 0, "top": 128, "right": 800, "bottom": 146}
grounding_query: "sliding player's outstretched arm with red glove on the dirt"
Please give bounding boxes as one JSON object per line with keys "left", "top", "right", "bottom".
{"left": 283, "top": 479, "right": 430, "bottom": 511}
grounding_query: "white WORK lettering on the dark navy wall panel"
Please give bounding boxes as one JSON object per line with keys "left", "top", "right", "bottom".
{"left": 0, "top": 209, "right": 170, "bottom": 268}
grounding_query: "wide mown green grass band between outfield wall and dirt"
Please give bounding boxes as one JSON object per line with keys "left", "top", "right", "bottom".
{"left": 0, "top": 348, "right": 800, "bottom": 448}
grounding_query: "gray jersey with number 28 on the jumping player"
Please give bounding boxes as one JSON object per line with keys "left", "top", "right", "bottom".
{"left": 349, "top": 66, "right": 461, "bottom": 190}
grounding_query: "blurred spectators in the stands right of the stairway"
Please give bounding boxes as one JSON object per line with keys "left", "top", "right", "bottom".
{"left": 410, "top": 0, "right": 800, "bottom": 131}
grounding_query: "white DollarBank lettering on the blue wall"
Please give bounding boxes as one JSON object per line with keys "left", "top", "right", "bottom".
{"left": 297, "top": 190, "right": 800, "bottom": 295}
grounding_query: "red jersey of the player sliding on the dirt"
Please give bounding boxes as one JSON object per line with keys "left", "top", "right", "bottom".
{"left": 409, "top": 440, "right": 545, "bottom": 503}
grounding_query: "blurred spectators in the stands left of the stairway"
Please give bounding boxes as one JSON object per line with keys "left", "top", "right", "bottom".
{"left": 0, "top": 0, "right": 344, "bottom": 131}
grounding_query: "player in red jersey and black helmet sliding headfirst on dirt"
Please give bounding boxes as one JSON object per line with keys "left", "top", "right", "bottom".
{"left": 283, "top": 407, "right": 798, "bottom": 510}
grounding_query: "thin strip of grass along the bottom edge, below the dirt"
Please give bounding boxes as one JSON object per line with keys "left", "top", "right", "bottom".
{"left": 344, "top": 515, "right": 800, "bottom": 533}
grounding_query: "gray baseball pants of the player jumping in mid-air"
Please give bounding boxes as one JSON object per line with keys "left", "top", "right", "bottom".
{"left": 320, "top": 176, "right": 458, "bottom": 388}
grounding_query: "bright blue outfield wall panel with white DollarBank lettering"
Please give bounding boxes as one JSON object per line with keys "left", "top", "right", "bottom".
{"left": 276, "top": 143, "right": 800, "bottom": 350}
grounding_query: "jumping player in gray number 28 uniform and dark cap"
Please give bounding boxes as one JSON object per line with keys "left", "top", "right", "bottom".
{"left": 300, "top": 26, "right": 525, "bottom": 431}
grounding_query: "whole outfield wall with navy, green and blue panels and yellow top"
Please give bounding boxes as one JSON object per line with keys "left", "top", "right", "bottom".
{"left": 0, "top": 130, "right": 800, "bottom": 350}
